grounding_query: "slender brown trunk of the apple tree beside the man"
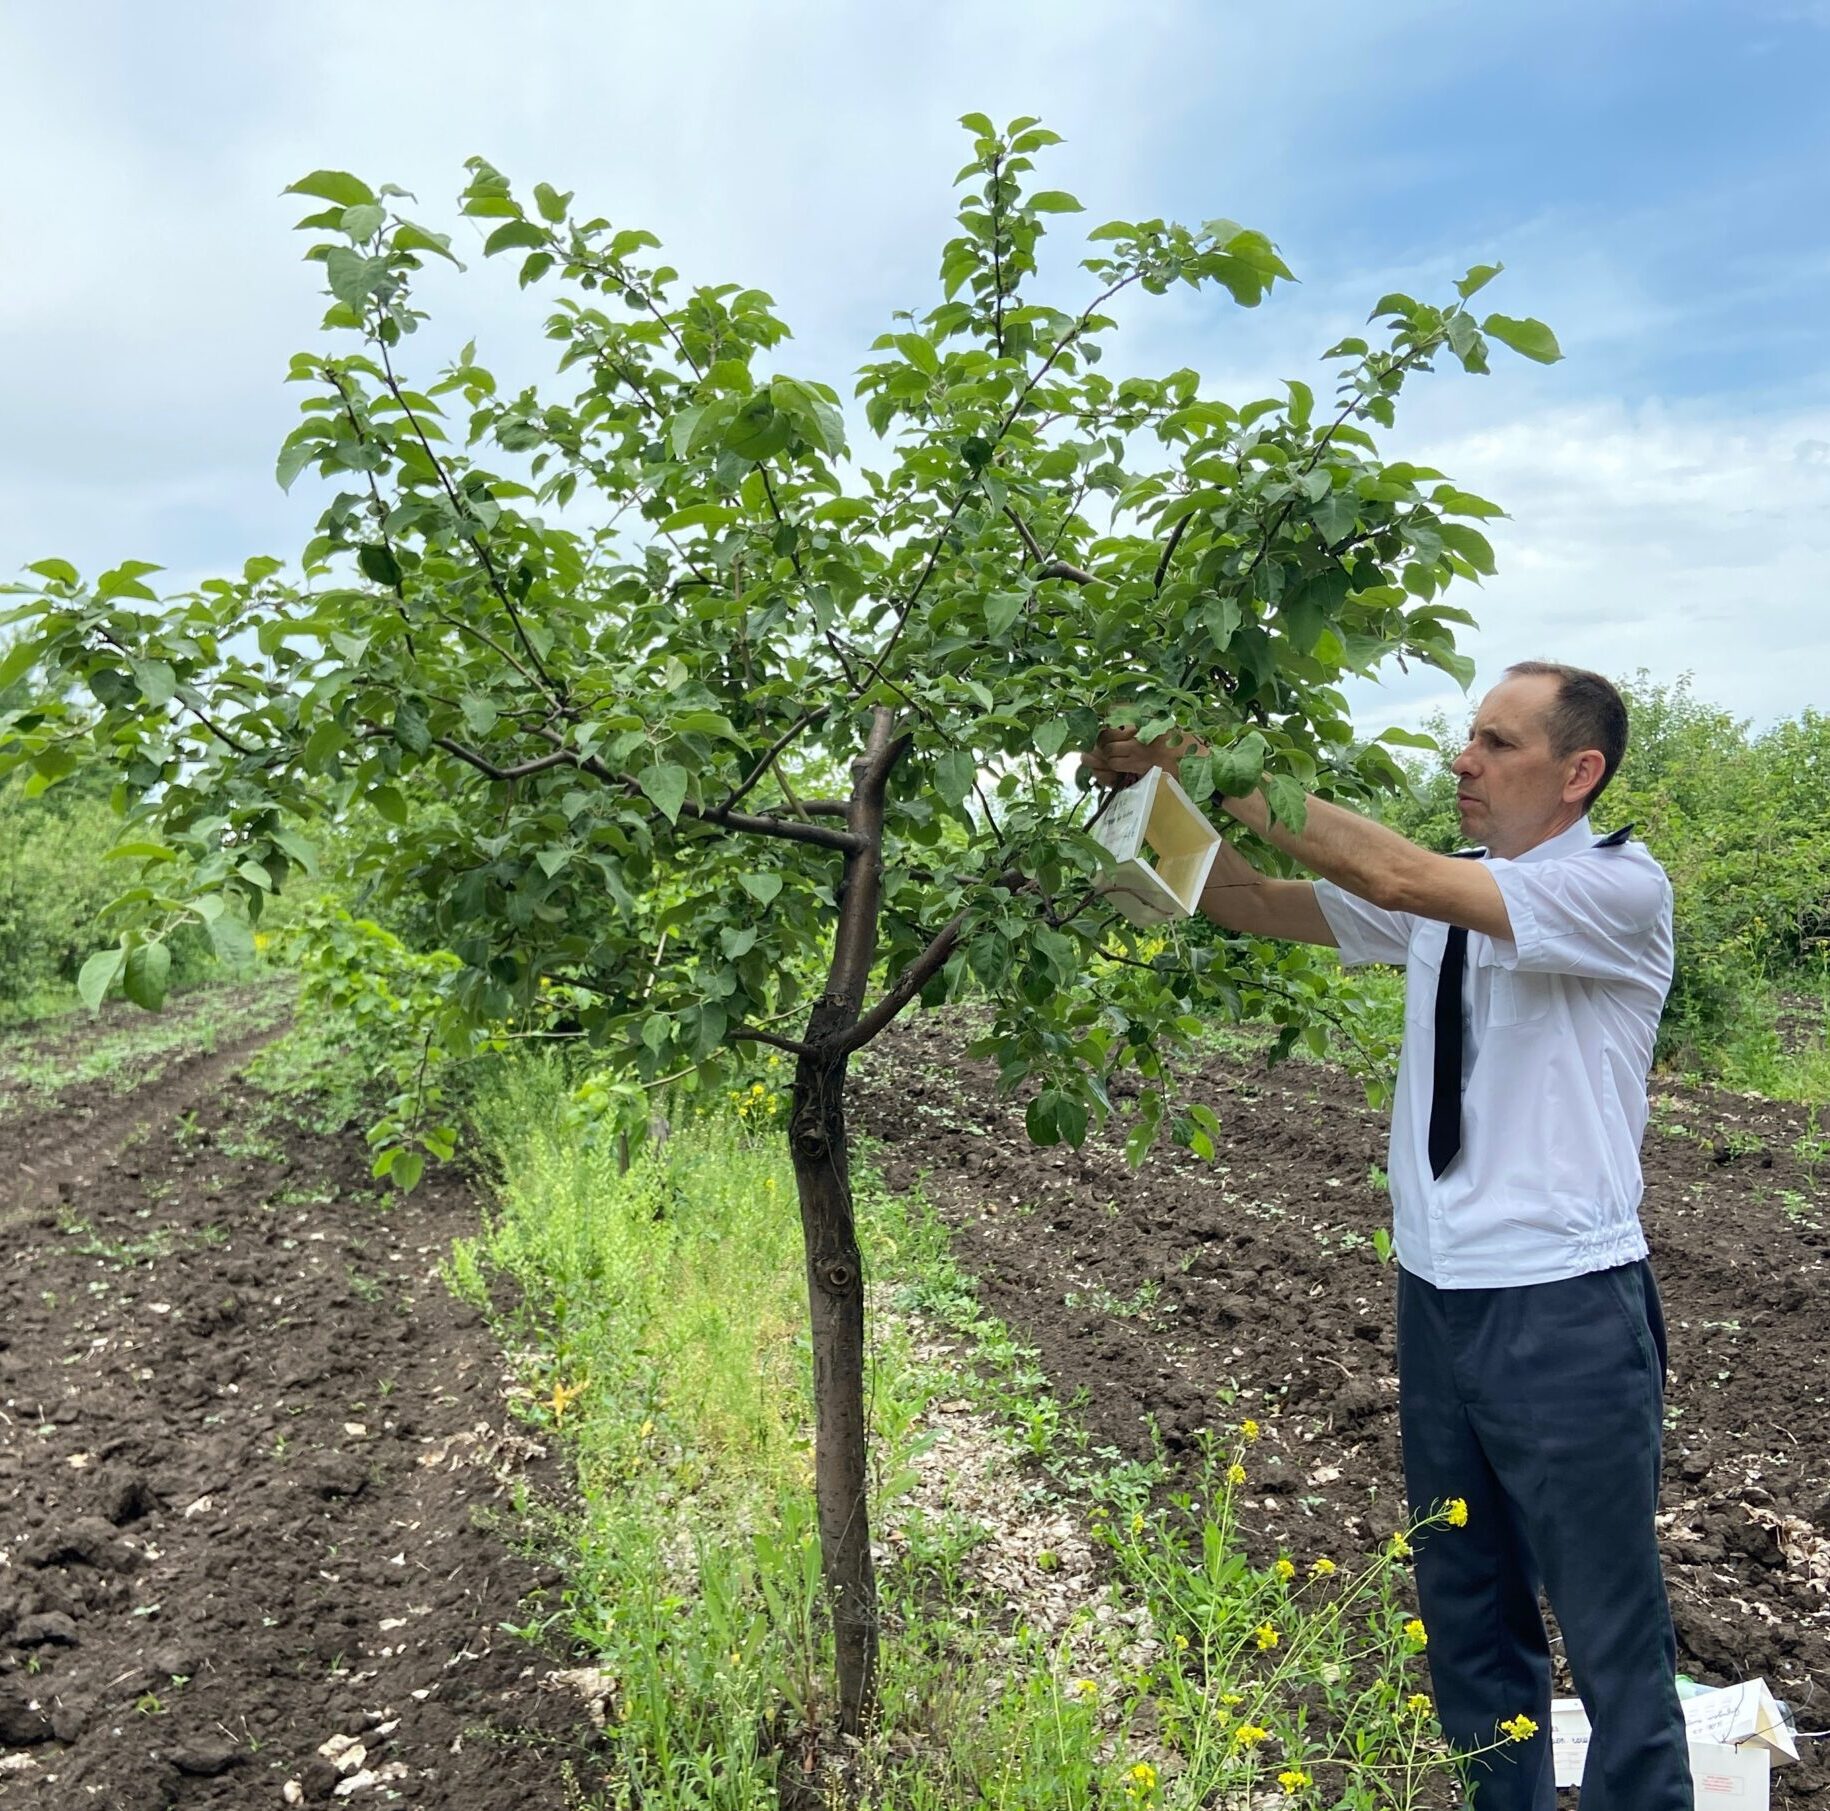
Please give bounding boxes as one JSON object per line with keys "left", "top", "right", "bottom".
{"left": 789, "top": 708, "right": 908, "bottom": 1736}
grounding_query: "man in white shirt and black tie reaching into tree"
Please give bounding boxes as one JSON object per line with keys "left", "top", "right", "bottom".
{"left": 1083, "top": 660, "right": 1693, "bottom": 1811}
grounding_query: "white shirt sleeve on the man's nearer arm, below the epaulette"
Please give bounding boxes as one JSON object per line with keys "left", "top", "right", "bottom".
{"left": 1488, "top": 849, "right": 1671, "bottom": 981}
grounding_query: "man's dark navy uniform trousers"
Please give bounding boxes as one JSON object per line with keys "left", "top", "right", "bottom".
{"left": 1398, "top": 1262, "right": 1695, "bottom": 1811}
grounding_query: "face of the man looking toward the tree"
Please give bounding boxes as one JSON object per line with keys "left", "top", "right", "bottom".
{"left": 1449, "top": 673, "right": 1599, "bottom": 858}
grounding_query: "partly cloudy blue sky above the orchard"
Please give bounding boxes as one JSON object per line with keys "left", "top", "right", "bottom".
{"left": 0, "top": 0, "right": 1830, "bottom": 734}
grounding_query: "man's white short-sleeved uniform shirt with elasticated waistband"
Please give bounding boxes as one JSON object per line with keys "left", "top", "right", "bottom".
{"left": 1316, "top": 818, "right": 1673, "bottom": 1290}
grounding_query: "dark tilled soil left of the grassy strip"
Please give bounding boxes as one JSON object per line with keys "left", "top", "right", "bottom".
{"left": 0, "top": 1008, "right": 607, "bottom": 1811}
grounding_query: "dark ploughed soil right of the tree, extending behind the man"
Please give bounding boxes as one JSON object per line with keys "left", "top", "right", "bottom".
{"left": 855, "top": 1019, "right": 1830, "bottom": 1806}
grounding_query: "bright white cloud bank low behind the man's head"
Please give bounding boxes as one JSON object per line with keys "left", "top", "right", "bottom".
{"left": 1332, "top": 402, "right": 1830, "bottom": 739}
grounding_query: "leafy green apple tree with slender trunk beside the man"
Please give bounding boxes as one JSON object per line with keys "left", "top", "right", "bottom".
{"left": 0, "top": 113, "right": 1557, "bottom": 1731}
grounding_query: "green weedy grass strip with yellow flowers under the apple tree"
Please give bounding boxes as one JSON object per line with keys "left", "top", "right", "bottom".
{"left": 450, "top": 1057, "right": 1535, "bottom": 1811}
